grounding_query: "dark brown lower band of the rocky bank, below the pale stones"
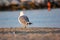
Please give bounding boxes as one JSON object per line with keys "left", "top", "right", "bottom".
{"left": 0, "top": 1, "right": 60, "bottom": 11}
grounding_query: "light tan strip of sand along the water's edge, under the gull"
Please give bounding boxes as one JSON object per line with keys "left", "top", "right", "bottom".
{"left": 0, "top": 27, "right": 60, "bottom": 33}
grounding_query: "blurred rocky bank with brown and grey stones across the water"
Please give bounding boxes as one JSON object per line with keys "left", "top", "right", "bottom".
{"left": 0, "top": 0, "right": 60, "bottom": 11}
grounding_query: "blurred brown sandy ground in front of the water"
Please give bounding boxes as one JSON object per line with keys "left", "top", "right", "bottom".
{"left": 0, "top": 28, "right": 60, "bottom": 40}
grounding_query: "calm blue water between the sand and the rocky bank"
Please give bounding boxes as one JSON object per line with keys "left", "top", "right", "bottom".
{"left": 0, "top": 9, "right": 60, "bottom": 28}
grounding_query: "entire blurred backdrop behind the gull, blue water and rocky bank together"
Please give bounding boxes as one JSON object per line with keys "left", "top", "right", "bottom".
{"left": 0, "top": 0, "right": 60, "bottom": 28}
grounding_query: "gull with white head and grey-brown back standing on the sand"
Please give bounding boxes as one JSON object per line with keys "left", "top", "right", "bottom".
{"left": 18, "top": 11, "right": 32, "bottom": 28}
